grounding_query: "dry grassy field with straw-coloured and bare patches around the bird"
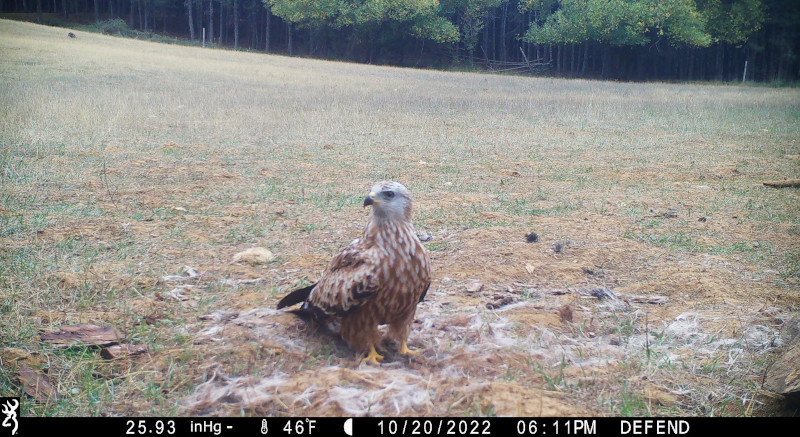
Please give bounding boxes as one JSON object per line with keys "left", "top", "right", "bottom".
{"left": 0, "top": 20, "right": 800, "bottom": 416}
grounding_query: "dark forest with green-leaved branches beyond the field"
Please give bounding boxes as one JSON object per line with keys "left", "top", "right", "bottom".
{"left": 0, "top": 0, "right": 800, "bottom": 82}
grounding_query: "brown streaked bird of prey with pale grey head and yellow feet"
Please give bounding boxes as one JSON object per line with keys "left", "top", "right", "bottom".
{"left": 278, "top": 181, "right": 431, "bottom": 365}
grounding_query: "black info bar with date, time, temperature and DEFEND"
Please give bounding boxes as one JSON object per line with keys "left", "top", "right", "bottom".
{"left": 9, "top": 417, "right": 800, "bottom": 437}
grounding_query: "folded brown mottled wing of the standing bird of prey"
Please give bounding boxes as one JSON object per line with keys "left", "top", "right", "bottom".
{"left": 304, "top": 240, "right": 380, "bottom": 316}
